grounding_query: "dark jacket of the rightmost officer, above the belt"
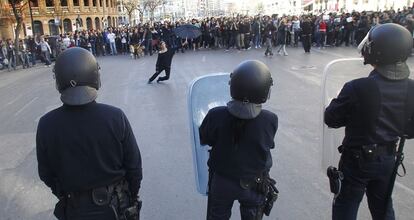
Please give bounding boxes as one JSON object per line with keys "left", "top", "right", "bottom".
{"left": 325, "top": 70, "right": 414, "bottom": 146}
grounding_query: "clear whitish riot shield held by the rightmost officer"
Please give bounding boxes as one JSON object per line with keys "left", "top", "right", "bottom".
{"left": 320, "top": 58, "right": 372, "bottom": 168}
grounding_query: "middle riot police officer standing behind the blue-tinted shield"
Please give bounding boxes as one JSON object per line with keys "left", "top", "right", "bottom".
{"left": 199, "top": 61, "right": 278, "bottom": 220}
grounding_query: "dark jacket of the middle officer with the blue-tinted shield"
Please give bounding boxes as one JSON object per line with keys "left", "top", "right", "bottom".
{"left": 199, "top": 106, "right": 278, "bottom": 179}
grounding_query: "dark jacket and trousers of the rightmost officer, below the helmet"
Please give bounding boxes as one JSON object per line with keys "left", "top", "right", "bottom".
{"left": 325, "top": 70, "right": 414, "bottom": 220}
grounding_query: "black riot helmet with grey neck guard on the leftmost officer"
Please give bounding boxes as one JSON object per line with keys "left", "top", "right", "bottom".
{"left": 53, "top": 47, "right": 101, "bottom": 105}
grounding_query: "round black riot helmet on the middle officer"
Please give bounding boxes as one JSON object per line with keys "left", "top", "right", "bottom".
{"left": 230, "top": 60, "right": 273, "bottom": 104}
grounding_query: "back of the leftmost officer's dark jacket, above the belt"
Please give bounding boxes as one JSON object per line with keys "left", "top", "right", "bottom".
{"left": 37, "top": 102, "right": 138, "bottom": 192}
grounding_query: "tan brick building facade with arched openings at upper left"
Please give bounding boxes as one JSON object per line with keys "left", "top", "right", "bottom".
{"left": 0, "top": 0, "right": 120, "bottom": 39}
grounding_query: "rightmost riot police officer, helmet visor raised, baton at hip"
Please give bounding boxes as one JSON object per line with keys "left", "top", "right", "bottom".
{"left": 324, "top": 24, "right": 414, "bottom": 220}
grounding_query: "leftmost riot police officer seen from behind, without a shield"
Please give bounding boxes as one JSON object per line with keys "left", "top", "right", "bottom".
{"left": 36, "top": 48, "right": 142, "bottom": 220}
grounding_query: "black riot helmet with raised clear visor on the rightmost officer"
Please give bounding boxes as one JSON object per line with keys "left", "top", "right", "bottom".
{"left": 358, "top": 23, "right": 413, "bottom": 65}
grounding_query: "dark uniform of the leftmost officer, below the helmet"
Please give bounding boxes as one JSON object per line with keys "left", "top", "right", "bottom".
{"left": 36, "top": 101, "right": 142, "bottom": 220}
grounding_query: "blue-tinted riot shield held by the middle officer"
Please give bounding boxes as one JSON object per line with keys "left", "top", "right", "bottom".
{"left": 188, "top": 73, "right": 231, "bottom": 195}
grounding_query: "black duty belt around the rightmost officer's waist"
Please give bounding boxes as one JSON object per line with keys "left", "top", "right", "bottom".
{"left": 338, "top": 142, "right": 396, "bottom": 157}
